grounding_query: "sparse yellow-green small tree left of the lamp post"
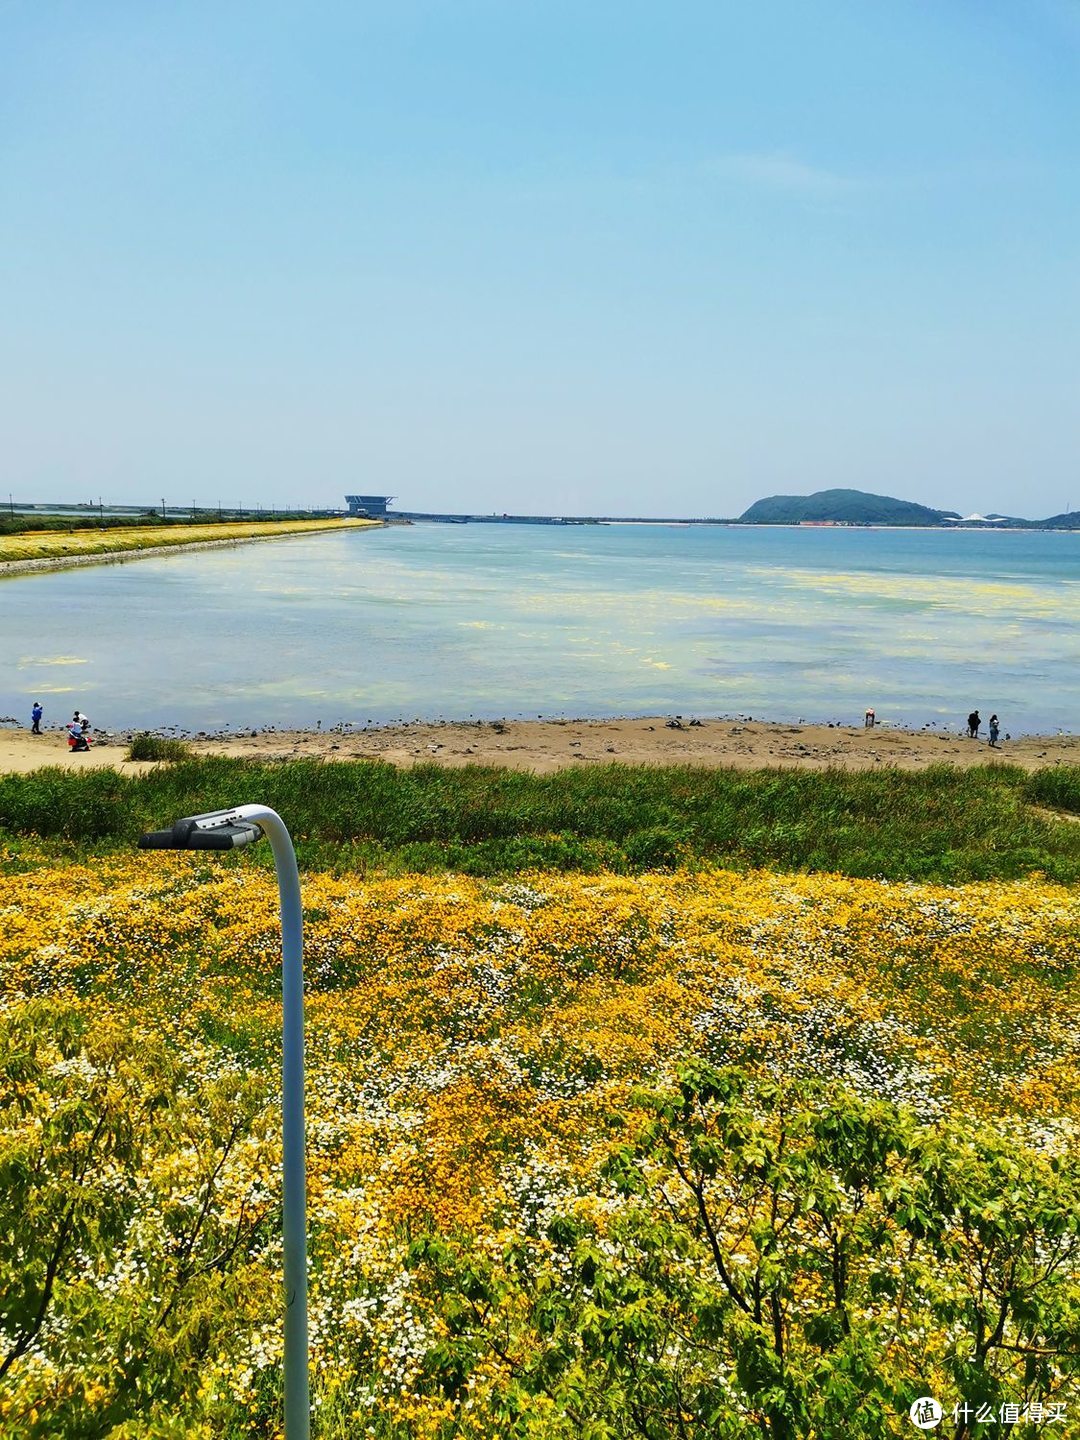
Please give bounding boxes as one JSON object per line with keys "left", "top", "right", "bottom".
{"left": 0, "top": 1001, "right": 276, "bottom": 1440}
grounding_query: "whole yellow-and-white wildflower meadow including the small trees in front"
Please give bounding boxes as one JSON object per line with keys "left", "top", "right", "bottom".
{"left": 0, "top": 854, "right": 1080, "bottom": 1440}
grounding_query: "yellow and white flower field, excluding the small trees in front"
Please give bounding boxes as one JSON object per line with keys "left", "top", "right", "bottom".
{"left": 0, "top": 857, "right": 1080, "bottom": 1436}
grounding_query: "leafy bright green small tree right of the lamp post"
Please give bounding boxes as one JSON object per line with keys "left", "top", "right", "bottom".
{"left": 403, "top": 1064, "right": 1080, "bottom": 1440}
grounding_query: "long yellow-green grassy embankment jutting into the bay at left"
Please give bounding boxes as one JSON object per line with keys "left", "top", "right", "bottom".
{"left": 0, "top": 516, "right": 377, "bottom": 563}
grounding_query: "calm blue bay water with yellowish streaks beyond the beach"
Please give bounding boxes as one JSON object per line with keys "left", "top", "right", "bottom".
{"left": 0, "top": 524, "right": 1080, "bottom": 734}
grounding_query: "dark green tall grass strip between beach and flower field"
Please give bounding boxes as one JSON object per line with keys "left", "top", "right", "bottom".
{"left": 0, "top": 757, "right": 1080, "bottom": 884}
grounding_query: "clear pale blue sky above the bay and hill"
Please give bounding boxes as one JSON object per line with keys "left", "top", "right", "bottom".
{"left": 0, "top": 0, "right": 1080, "bottom": 517}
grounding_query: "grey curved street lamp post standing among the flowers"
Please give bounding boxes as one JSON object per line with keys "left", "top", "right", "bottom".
{"left": 138, "top": 805, "right": 311, "bottom": 1440}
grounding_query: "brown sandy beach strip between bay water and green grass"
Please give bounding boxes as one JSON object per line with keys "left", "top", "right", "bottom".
{"left": 0, "top": 717, "right": 1080, "bottom": 773}
